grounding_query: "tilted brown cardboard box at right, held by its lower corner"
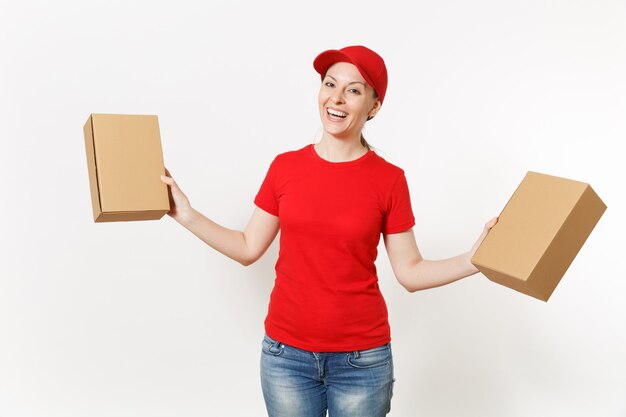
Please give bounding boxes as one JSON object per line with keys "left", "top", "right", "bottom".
{"left": 472, "top": 171, "right": 606, "bottom": 301}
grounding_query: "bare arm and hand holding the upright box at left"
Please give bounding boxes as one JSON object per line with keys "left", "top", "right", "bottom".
{"left": 161, "top": 170, "right": 279, "bottom": 266}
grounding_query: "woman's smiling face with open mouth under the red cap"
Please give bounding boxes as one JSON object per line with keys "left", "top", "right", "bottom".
{"left": 318, "top": 62, "right": 380, "bottom": 138}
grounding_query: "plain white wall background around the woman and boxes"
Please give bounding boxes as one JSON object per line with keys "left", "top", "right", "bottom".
{"left": 0, "top": 0, "right": 626, "bottom": 417}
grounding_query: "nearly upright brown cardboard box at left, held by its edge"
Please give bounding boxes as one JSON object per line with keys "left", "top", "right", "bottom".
{"left": 83, "top": 110, "right": 170, "bottom": 222}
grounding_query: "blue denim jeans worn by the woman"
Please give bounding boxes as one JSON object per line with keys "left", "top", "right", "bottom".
{"left": 261, "top": 335, "right": 394, "bottom": 417}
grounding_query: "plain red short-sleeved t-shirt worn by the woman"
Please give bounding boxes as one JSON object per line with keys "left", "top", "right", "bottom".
{"left": 254, "top": 144, "right": 415, "bottom": 352}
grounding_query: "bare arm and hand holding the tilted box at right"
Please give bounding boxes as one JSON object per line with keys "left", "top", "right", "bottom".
{"left": 383, "top": 218, "right": 498, "bottom": 292}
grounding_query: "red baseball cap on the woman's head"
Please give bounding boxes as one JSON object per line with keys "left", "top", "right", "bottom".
{"left": 313, "top": 45, "right": 387, "bottom": 104}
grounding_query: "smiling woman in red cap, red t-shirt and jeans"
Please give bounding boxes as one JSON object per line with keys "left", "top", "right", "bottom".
{"left": 162, "top": 46, "right": 497, "bottom": 417}
